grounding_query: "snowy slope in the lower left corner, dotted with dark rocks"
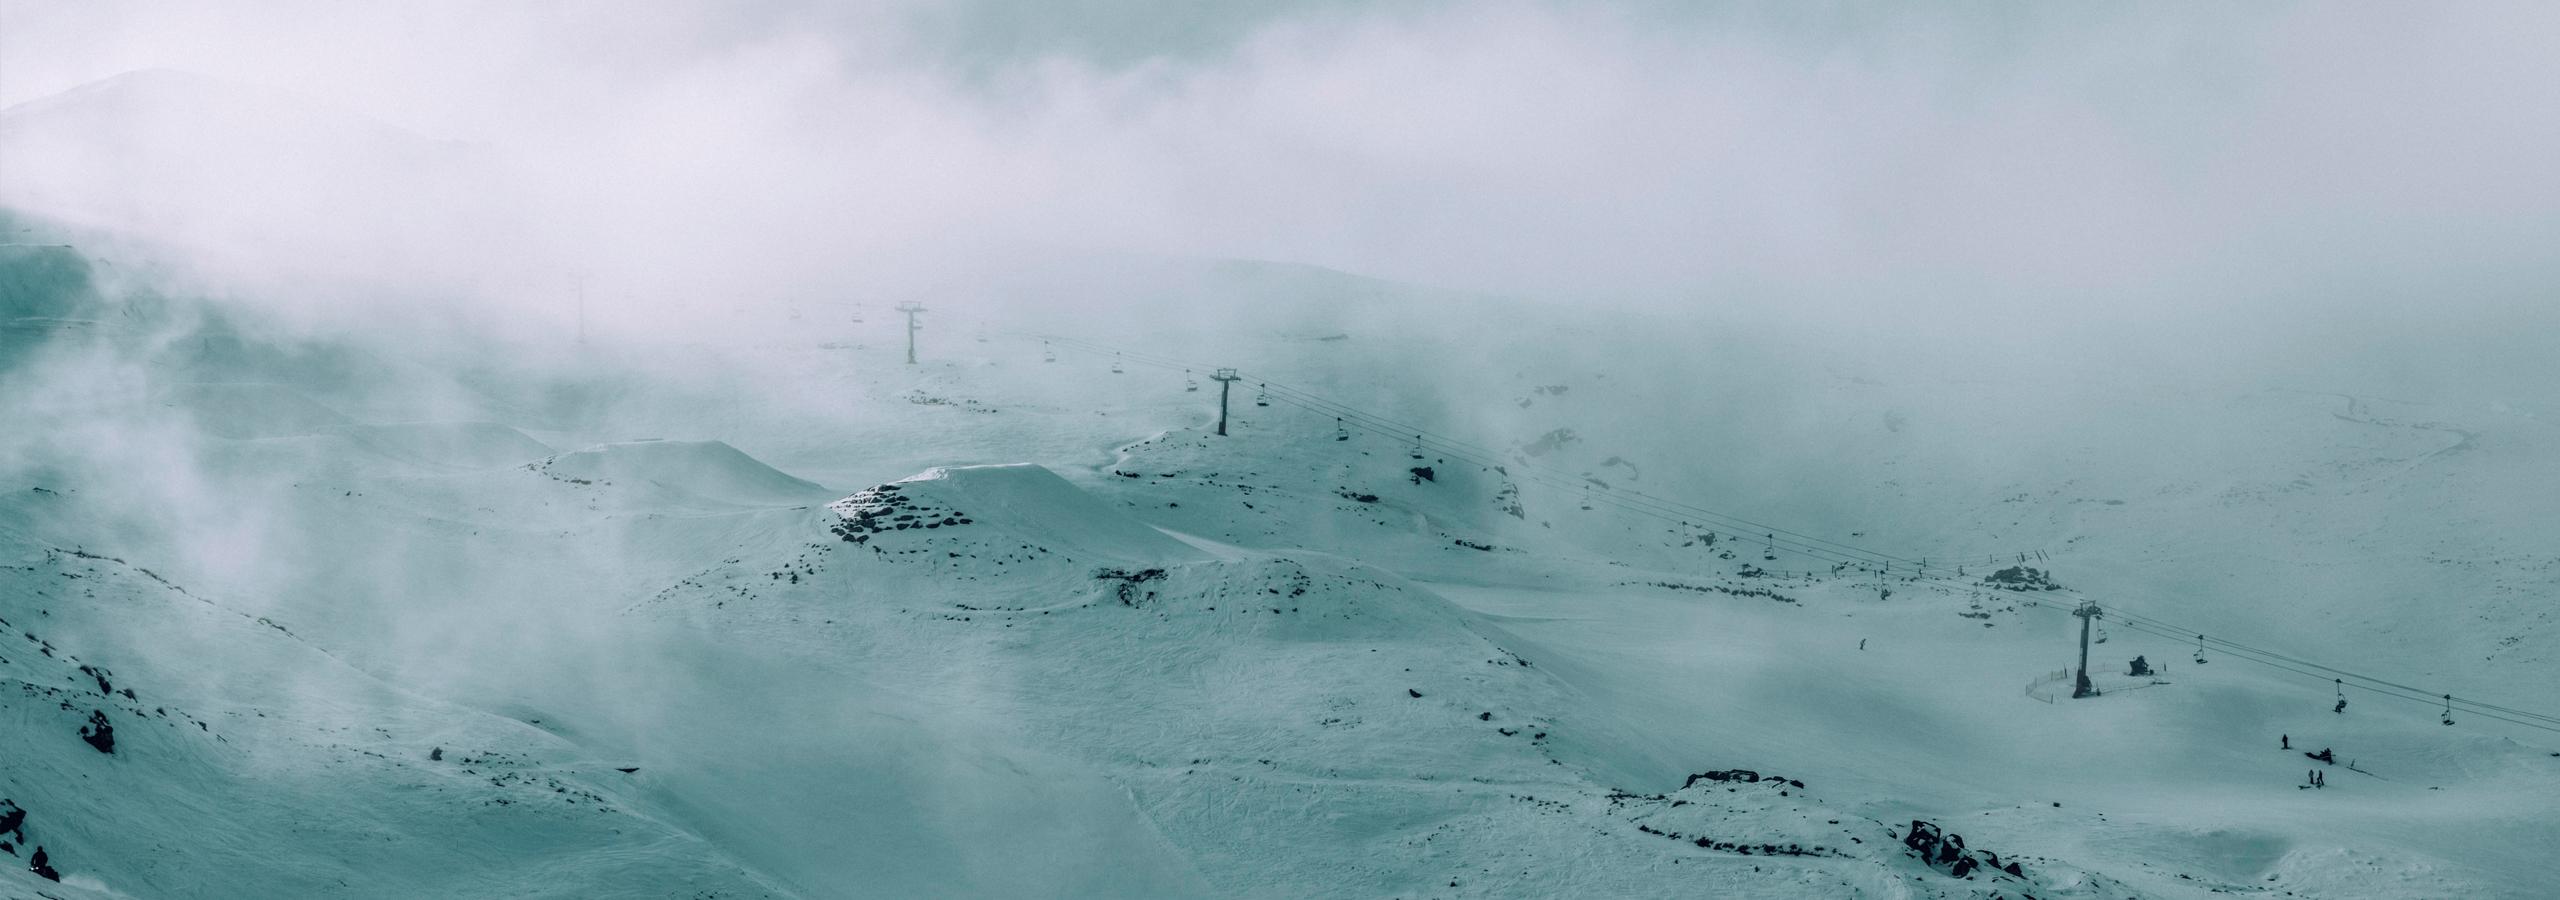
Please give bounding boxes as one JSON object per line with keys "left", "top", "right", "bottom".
{"left": 0, "top": 508, "right": 768, "bottom": 897}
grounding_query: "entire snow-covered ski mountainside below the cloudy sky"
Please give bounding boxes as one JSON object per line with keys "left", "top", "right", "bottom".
{"left": 0, "top": 237, "right": 2560, "bottom": 897}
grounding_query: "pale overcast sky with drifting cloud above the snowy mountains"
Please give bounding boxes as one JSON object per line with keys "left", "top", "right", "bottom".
{"left": 0, "top": 0, "right": 2560, "bottom": 337}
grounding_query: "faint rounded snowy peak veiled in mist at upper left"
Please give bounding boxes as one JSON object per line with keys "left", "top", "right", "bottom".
{"left": 0, "top": 69, "right": 504, "bottom": 281}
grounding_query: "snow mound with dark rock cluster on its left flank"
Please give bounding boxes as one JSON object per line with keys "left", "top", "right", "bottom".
{"left": 829, "top": 463, "right": 1206, "bottom": 563}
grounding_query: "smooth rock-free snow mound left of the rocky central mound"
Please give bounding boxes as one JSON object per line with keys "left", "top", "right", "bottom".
{"left": 532, "top": 440, "right": 827, "bottom": 506}
